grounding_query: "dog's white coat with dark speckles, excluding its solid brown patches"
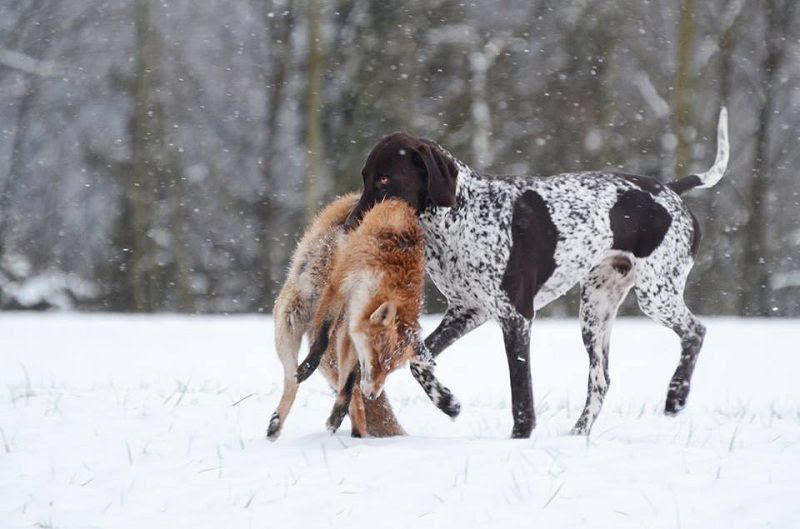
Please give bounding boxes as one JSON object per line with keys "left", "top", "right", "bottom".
{"left": 421, "top": 156, "right": 704, "bottom": 436}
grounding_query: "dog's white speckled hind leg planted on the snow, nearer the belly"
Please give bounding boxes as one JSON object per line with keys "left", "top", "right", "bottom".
{"left": 572, "top": 254, "right": 634, "bottom": 435}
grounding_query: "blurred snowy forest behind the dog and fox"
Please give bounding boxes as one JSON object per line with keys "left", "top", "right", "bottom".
{"left": 0, "top": 0, "right": 800, "bottom": 316}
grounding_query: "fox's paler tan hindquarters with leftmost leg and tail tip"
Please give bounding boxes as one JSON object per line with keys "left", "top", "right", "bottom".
{"left": 267, "top": 194, "right": 405, "bottom": 441}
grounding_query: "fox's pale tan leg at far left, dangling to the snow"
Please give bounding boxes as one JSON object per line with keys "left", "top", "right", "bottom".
{"left": 267, "top": 306, "right": 303, "bottom": 441}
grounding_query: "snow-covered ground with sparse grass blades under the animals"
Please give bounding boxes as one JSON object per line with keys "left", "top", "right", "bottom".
{"left": 0, "top": 314, "right": 800, "bottom": 529}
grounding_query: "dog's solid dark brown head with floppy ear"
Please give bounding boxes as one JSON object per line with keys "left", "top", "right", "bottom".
{"left": 345, "top": 132, "right": 458, "bottom": 229}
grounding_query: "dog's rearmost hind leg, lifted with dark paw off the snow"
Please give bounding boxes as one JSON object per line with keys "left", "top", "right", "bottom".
{"left": 635, "top": 262, "right": 706, "bottom": 415}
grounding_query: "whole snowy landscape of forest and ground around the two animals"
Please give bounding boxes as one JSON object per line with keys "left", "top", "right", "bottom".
{"left": 0, "top": 0, "right": 800, "bottom": 529}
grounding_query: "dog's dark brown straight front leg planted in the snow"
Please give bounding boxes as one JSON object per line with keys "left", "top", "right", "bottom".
{"left": 500, "top": 315, "right": 536, "bottom": 439}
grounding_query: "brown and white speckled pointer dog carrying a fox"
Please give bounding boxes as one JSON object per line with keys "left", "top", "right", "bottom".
{"left": 345, "top": 108, "right": 729, "bottom": 438}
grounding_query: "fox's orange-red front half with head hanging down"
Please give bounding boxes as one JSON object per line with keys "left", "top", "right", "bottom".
{"left": 297, "top": 200, "right": 430, "bottom": 435}
